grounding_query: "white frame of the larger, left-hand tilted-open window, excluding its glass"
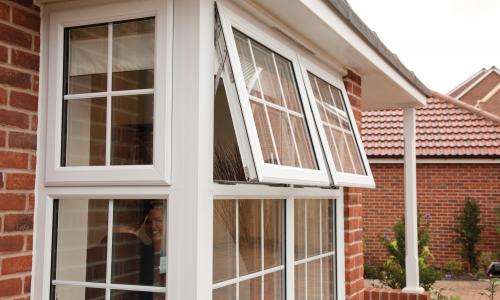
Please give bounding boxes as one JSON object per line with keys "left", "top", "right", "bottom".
{"left": 217, "top": 1, "right": 330, "bottom": 186}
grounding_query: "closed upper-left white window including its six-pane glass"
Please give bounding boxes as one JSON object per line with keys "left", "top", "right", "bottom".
{"left": 46, "top": 0, "right": 172, "bottom": 185}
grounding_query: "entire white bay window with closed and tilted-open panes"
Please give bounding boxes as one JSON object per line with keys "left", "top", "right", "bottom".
{"left": 34, "top": 0, "right": 373, "bottom": 300}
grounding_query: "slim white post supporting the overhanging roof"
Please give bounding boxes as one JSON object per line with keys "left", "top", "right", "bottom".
{"left": 403, "top": 108, "right": 424, "bottom": 293}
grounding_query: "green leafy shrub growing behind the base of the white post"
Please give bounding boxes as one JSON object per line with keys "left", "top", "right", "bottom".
{"left": 380, "top": 214, "right": 442, "bottom": 291}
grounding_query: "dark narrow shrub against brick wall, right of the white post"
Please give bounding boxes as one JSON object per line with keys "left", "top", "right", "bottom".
{"left": 455, "top": 198, "right": 482, "bottom": 271}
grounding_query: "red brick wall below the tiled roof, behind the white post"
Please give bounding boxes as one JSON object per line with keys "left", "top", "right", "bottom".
{"left": 363, "top": 164, "right": 500, "bottom": 265}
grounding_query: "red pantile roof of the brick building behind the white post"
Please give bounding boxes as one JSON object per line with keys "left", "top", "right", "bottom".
{"left": 361, "top": 93, "right": 500, "bottom": 158}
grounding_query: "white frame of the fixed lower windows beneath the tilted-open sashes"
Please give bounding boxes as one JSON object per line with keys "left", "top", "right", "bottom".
{"left": 212, "top": 183, "right": 345, "bottom": 300}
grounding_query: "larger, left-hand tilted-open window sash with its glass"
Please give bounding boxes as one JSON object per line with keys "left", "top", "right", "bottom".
{"left": 216, "top": 3, "right": 330, "bottom": 186}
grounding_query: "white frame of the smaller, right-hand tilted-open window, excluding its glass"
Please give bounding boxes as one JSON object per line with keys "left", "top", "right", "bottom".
{"left": 299, "top": 56, "right": 375, "bottom": 188}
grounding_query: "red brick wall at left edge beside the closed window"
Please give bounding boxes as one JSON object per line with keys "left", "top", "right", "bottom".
{"left": 0, "top": 0, "right": 40, "bottom": 299}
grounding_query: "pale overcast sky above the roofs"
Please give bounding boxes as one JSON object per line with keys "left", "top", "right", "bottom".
{"left": 347, "top": 0, "right": 500, "bottom": 94}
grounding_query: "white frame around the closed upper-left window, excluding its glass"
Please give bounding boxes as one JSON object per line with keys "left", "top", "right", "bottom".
{"left": 45, "top": 0, "right": 173, "bottom": 186}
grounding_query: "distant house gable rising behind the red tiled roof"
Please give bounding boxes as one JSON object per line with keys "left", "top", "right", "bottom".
{"left": 448, "top": 66, "right": 500, "bottom": 116}
